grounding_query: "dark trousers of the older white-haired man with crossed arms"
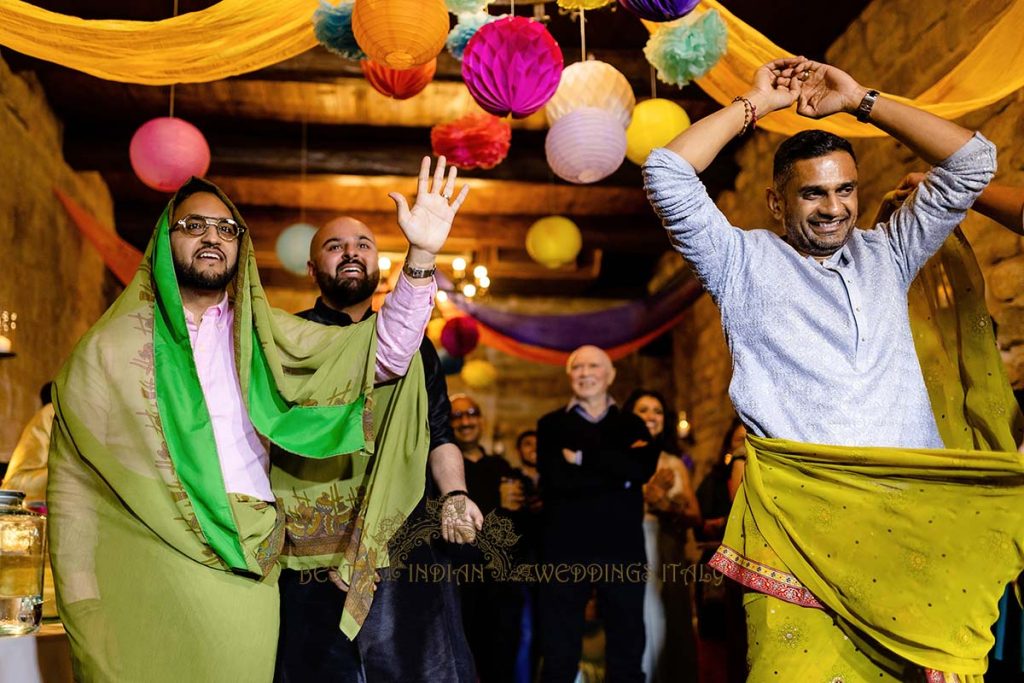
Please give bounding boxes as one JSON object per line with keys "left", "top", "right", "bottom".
{"left": 540, "top": 582, "right": 644, "bottom": 683}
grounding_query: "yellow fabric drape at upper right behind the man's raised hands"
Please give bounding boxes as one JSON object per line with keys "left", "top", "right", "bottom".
{"left": 644, "top": 0, "right": 1024, "bottom": 137}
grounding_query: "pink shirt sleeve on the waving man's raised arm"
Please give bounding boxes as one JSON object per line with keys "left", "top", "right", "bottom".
{"left": 375, "top": 273, "right": 437, "bottom": 382}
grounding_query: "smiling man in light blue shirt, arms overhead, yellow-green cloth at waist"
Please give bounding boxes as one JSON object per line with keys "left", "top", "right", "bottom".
{"left": 644, "top": 57, "right": 1024, "bottom": 683}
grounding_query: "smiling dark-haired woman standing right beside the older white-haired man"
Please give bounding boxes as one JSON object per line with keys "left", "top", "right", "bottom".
{"left": 623, "top": 389, "right": 700, "bottom": 683}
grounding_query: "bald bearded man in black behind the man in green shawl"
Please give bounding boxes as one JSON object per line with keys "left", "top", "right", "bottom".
{"left": 278, "top": 215, "right": 483, "bottom": 683}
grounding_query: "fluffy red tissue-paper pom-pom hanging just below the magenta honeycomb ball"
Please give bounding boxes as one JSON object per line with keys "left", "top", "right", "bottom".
{"left": 430, "top": 113, "right": 512, "bottom": 170}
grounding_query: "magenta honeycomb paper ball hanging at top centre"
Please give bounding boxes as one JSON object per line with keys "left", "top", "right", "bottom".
{"left": 462, "top": 16, "right": 562, "bottom": 119}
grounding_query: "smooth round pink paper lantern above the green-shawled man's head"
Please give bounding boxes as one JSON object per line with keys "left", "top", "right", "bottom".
{"left": 128, "top": 117, "right": 210, "bottom": 193}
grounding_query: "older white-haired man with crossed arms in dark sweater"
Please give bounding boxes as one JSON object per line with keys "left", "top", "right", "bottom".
{"left": 537, "top": 346, "right": 659, "bottom": 683}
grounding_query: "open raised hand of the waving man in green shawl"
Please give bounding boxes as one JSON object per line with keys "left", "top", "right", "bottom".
{"left": 388, "top": 157, "right": 469, "bottom": 260}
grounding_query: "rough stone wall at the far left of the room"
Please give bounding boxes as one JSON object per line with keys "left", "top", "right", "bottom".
{"left": 0, "top": 59, "right": 117, "bottom": 461}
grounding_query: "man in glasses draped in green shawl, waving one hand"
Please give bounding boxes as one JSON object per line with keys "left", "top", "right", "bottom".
{"left": 48, "top": 157, "right": 468, "bottom": 683}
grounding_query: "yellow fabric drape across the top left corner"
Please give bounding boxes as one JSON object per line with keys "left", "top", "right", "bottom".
{"left": 0, "top": 0, "right": 317, "bottom": 85}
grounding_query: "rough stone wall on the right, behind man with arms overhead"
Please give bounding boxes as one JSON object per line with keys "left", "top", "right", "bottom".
{"left": 662, "top": 0, "right": 1024, "bottom": 481}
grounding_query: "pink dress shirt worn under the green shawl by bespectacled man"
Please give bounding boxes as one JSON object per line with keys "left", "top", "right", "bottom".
{"left": 185, "top": 274, "right": 437, "bottom": 501}
